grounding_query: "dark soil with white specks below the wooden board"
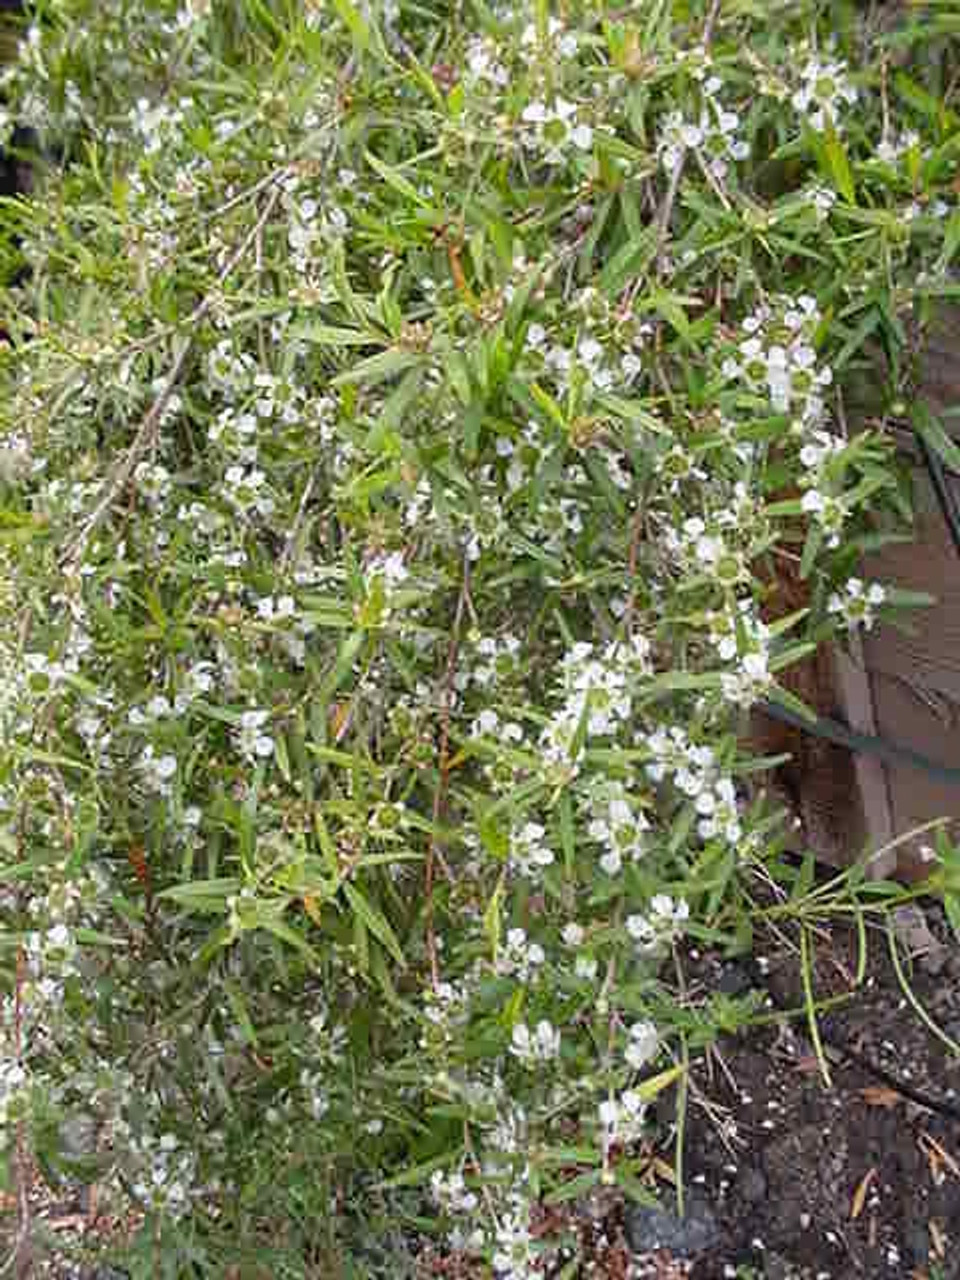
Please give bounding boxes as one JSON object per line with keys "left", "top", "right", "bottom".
{"left": 632, "top": 908, "right": 960, "bottom": 1280}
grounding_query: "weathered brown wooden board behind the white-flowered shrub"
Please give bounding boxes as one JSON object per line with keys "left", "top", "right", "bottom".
{"left": 751, "top": 308, "right": 960, "bottom": 878}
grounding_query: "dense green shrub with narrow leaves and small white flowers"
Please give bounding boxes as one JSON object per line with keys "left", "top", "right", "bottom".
{"left": 0, "top": 0, "right": 960, "bottom": 1280}
